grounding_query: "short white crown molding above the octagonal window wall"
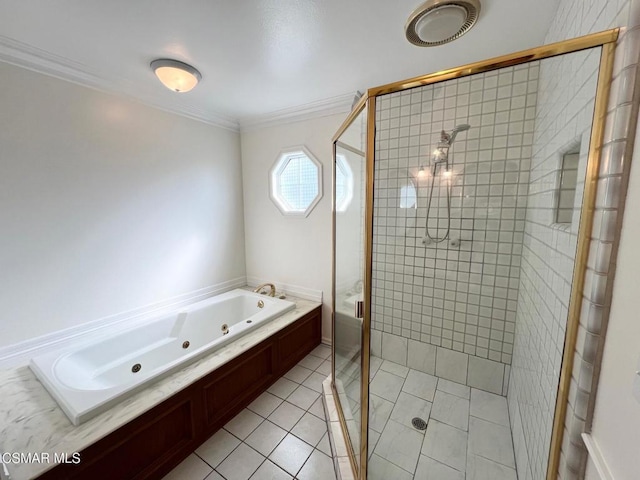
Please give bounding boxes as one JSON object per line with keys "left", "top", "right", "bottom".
{"left": 240, "top": 93, "right": 354, "bottom": 132}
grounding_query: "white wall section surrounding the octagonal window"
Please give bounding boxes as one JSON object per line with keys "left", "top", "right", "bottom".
{"left": 241, "top": 113, "right": 346, "bottom": 341}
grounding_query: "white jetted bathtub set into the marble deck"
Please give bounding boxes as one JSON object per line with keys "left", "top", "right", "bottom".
{"left": 29, "top": 289, "right": 295, "bottom": 425}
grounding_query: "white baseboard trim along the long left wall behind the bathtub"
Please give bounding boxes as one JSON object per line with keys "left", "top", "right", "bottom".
{"left": 0, "top": 277, "right": 247, "bottom": 368}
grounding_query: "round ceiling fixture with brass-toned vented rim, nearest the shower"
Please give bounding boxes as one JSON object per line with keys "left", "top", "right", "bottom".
{"left": 405, "top": 0, "right": 480, "bottom": 47}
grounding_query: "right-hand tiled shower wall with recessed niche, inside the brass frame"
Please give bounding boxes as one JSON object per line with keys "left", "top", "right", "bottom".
{"left": 508, "top": 49, "right": 600, "bottom": 480}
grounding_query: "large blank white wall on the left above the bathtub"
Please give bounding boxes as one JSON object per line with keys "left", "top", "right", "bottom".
{"left": 0, "top": 64, "right": 245, "bottom": 347}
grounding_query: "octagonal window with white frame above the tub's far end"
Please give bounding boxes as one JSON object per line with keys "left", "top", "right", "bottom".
{"left": 270, "top": 147, "right": 322, "bottom": 217}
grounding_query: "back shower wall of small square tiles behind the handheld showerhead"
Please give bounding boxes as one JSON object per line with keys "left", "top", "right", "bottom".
{"left": 372, "top": 63, "right": 539, "bottom": 393}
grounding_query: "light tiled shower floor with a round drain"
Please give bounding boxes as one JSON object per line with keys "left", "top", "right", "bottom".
{"left": 369, "top": 357, "right": 517, "bottom": 480}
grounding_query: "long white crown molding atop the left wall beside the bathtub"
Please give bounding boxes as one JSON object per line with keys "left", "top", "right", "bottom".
{"left": 0, "top": 35, "right": 240, "bottom": 132}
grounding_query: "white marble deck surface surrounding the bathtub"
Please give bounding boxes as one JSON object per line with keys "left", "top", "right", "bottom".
{"left": 0, "top": 297, "right": 320, "bottom": 480}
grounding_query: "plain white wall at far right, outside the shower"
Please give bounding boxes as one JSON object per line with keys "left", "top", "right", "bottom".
{"left": 588, "top": 109, "right": 640, "bottom": 480}
